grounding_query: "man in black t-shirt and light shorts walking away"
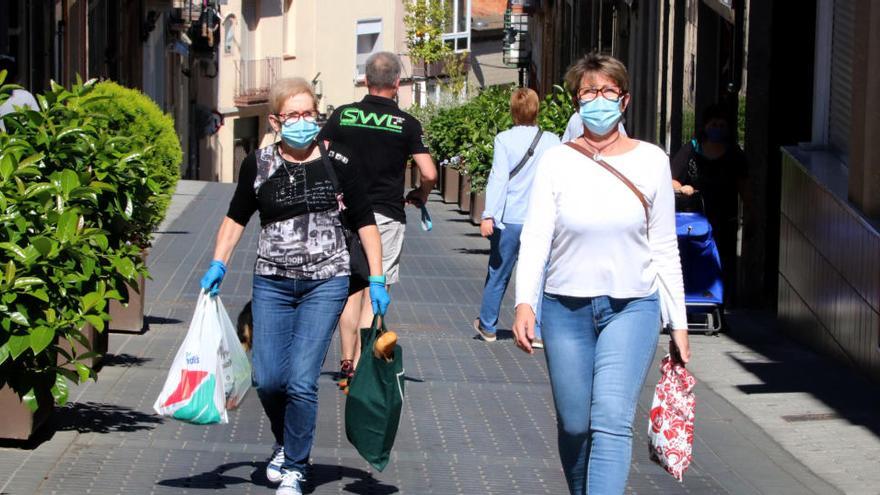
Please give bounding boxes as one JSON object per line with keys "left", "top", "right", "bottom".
{"left": 318, "top": 52, "right": 437, "bottom": 378}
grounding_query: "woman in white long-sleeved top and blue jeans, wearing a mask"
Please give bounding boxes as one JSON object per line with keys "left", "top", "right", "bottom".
{"left": 513, "top": 54, "right": 690, "bottom": 495}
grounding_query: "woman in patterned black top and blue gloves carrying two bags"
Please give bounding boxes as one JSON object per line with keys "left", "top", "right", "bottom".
{"left": 202, "top": 78, "right": 390, "bottom": 495}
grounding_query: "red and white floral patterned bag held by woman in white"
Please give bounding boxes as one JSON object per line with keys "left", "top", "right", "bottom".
{"left": 648, "top": 355, "right": 697, "bottom": 481}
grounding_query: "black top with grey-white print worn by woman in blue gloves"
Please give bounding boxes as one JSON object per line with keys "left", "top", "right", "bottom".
{"left": 226, "top": 143, "right": 376, "bottom": 280}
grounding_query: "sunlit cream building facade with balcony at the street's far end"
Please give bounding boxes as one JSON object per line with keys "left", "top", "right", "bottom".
{"left": 194, "top": 0, "right": 471, "bottom": 182}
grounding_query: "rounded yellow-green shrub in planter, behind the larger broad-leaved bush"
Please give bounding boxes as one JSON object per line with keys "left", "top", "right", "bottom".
{"left": 92, "top": 81, "right": 183, "bottom": 332}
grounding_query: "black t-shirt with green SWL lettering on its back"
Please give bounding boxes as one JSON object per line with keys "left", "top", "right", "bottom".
{"left": 319, "top": 95, "right": 428, "bottom": 222}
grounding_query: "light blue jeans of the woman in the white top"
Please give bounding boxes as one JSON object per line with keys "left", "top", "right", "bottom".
{"left": 544, "top": 293, "right": 660, "bottom": 495}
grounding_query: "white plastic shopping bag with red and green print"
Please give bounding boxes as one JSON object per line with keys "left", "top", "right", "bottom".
{"left": 153, "top": 292, "right": 250, "bottom": 424}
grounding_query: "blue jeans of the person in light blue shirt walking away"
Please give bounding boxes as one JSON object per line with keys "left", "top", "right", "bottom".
{"left": 480, "top": 223, "right": 541, "bottom": 339}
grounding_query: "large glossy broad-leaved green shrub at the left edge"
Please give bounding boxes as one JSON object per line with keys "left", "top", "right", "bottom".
{"left": 0, "top": 73, "right": 154, "bottom": 438}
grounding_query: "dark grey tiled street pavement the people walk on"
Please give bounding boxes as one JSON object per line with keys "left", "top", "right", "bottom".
{"left": 0, "top": 182, "right": 860, "bottom": 495}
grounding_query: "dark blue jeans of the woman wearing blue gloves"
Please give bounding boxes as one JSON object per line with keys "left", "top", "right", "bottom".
{"left": 253, "top": 275, "right": 348, "bottom": 472}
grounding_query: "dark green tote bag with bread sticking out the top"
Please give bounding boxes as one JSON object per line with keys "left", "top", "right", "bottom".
{"left": 345, "top": 317, "right": 404, "bottom": 471}
